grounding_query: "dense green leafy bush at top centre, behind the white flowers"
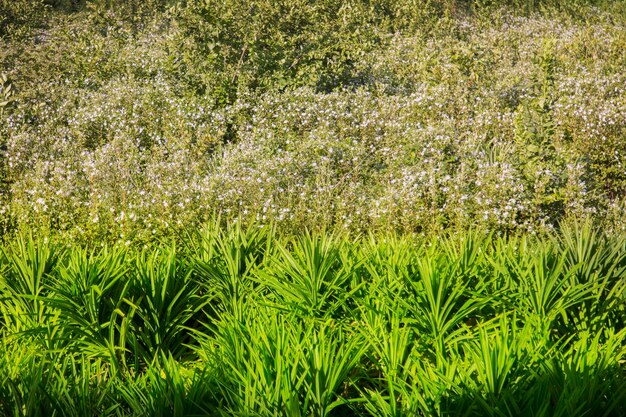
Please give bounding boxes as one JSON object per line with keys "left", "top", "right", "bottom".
{"left": 168, "top": 0, "right": 393, "bottom": 99}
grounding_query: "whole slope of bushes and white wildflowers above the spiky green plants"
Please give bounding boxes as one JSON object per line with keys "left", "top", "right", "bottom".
{"left": 0, "top": 0, "right": 626, "bottom": 243}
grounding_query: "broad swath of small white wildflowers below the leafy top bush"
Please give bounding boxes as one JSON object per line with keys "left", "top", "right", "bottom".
{"left": 0, "top": 8, "right": 626, "bottom": 241}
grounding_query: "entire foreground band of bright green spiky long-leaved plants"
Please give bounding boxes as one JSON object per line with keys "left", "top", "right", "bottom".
{"left": 0, "top": 221, "right": 626, "bottom": 416}
